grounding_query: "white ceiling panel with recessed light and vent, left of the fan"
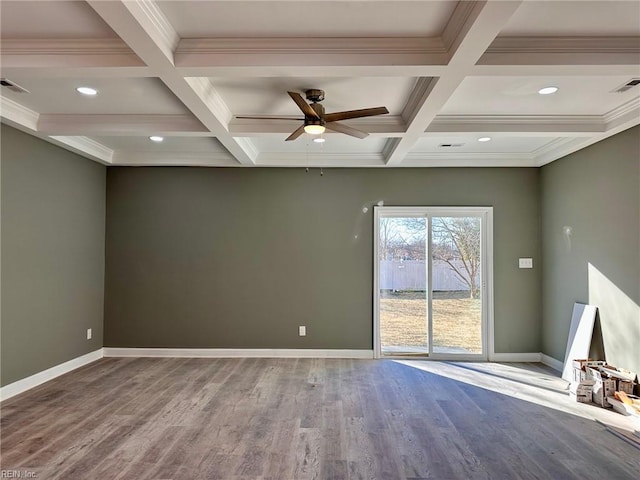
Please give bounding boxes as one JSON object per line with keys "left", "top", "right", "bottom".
{"left": 2, "top": 77, "right": 188, "bottom": 114}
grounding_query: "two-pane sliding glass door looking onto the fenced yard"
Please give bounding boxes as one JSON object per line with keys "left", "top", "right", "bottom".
{"left": 374, "top": 207, "right": 492, "bottom": 359}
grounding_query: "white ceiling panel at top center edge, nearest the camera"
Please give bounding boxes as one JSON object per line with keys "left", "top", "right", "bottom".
{"left": 158, "top": 1, "right": 456, "bottom": 38}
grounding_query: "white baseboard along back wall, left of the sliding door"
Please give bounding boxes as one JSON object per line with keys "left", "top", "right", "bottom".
{"left": 103, "top": 347, "right": 373, "bottom": 359}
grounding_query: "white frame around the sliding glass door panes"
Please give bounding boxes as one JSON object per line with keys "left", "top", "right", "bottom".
{"left": 373, "top": 206, "right": 494, "bottom": 360}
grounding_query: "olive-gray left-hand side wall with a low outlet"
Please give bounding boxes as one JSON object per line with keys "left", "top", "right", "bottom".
{"left": 0, "top": 125, "right": 106, "bottom": 385}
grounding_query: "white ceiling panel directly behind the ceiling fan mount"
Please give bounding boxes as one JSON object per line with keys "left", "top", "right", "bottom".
{"left": 211, "top": 77, "right": 416, "bottom": 115}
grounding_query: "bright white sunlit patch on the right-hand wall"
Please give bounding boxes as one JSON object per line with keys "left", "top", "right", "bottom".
{"left": 587, "top": 262, "right": 640, "bottom": 373}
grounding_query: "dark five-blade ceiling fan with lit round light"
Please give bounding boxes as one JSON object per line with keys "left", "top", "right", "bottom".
{"left": 236, "top": 89, "right": 389, "bottom": 142}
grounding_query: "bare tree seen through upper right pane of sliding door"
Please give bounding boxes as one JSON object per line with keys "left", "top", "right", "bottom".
{"left": 431, "top": 217, "right": 480, "bottom": 298}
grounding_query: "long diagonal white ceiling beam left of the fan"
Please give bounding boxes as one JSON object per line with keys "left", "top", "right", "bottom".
{"left": 88, "top": 0, "right": 255, "bottom": 165}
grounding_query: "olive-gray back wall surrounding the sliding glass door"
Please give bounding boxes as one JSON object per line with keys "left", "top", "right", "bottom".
{"left": 105, "top": 167, "right": 541, "bottom": 352}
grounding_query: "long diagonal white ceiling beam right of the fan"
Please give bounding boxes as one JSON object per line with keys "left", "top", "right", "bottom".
{"left": 386, "top": 1, "right": 521, "bottom": 166}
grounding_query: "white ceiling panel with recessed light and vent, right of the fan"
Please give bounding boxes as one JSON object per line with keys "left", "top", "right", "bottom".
{"left": 441, "top": 76, "right": 640, "bottom": 115}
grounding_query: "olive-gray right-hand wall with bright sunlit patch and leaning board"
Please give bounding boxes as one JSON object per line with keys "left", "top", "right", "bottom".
{"left": 541, "top": 127, "right": 640, "bottom": 372}
